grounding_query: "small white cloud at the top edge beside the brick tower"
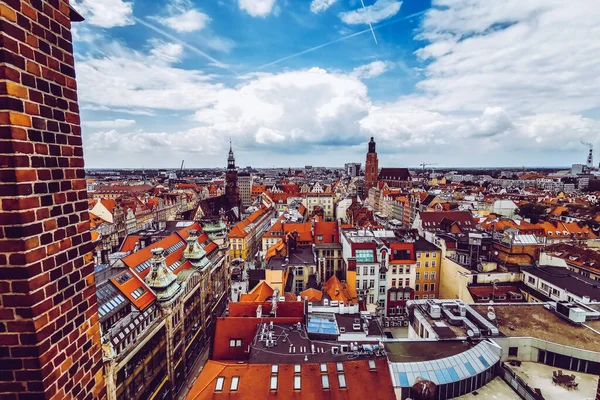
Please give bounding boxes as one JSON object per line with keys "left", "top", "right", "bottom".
{"left": 71, "top": 0, "right": 134, "bottom": 28}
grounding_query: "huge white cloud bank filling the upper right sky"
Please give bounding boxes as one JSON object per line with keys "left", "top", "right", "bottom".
{"left": 361, "top": 0, "right": 600, "bottom": 161}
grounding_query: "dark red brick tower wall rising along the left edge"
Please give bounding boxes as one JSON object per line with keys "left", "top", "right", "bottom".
{"left": 0, "top": 0, "right": 106, "bottom": 399}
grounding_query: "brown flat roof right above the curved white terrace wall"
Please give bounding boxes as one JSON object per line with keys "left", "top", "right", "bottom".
{"left": 471, "top": 303, "right": 600, "bottom": 352}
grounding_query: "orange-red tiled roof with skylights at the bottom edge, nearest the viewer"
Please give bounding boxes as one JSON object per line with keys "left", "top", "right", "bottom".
{"left": 187, "top": 357, "right": 396, "bottom": 400}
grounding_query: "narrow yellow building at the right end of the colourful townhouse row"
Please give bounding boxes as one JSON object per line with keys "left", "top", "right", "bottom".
{"left": 414, "top": 238, "right": 442, "bottom": 300}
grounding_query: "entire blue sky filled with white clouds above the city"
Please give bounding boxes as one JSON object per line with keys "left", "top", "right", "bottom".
{"left": 72, "top": 0, "right": 600, "bottom": 168}
